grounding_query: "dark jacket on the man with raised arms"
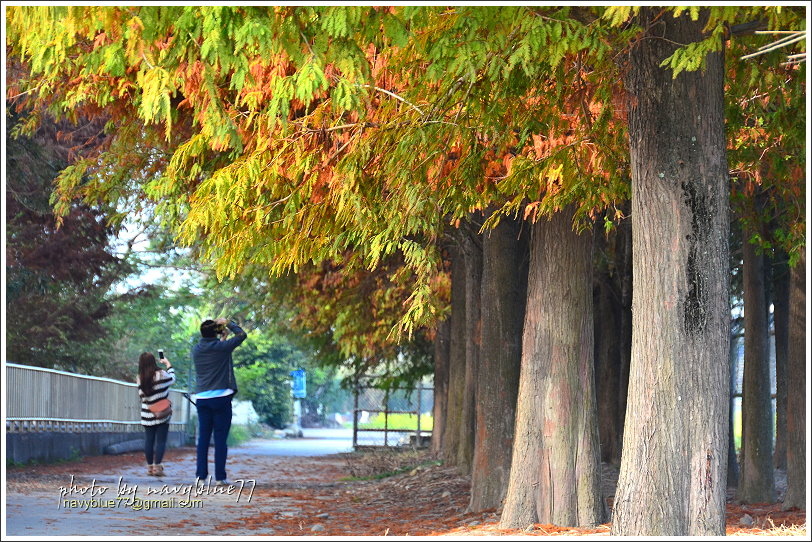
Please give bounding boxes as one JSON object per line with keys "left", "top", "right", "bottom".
{"left": 192, "top": 322, "right": 247, "bottom": 393}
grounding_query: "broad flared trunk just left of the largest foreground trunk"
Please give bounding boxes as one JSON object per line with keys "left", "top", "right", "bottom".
{"left": 494, "top": 208, "right": 604, "bottom": 528}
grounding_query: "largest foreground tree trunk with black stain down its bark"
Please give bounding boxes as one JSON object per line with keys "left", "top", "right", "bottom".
{"left": 612, "top": 7, "right": 730, "bottom": 536}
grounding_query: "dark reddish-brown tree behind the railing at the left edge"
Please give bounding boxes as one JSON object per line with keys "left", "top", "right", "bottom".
{"left": 5, "top": 110, "right": 130, "bottom": 372}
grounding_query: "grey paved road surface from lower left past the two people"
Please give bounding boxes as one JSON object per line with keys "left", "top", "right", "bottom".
{"left": 4, "top": 429, "right": 412, "bottom": 536}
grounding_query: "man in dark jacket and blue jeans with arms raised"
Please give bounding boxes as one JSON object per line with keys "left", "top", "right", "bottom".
{"left": 192, "top": 318, "right": 247, "bottom": 485}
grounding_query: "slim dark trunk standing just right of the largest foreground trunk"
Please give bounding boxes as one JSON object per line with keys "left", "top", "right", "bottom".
{"left": 736, "top": 223, "right": 775, "bottom": 503}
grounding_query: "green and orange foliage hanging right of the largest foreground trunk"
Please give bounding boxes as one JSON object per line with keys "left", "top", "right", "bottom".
{"left": 725, "top": 8, "right": 807, "bottom": 265}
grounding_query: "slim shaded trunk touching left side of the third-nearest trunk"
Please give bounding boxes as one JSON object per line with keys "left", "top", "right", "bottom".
{"left": 456, "top": 220, "right": 482, "bottom": 474}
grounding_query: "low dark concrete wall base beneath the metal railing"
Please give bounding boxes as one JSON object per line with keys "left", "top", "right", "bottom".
{"left": 6, "top": 431, "right": 187, "bottom": 463}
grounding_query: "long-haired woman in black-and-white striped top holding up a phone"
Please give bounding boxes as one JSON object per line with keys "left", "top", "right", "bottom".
{"left": 136, "top": 352, "right": 175, "bottom": 476}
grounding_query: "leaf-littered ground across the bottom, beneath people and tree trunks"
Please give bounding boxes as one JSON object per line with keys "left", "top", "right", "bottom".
{"left": 5, "top": 446, "right": 805, "bottom": 536}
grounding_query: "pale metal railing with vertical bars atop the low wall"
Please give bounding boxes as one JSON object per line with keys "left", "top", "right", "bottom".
{"left": 6, "top": 363, "right": 190, "bottom": 433}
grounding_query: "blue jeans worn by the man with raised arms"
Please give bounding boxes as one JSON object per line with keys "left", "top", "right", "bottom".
{"left": 197, "top": 395, "right": 233, "bottom": 480}
